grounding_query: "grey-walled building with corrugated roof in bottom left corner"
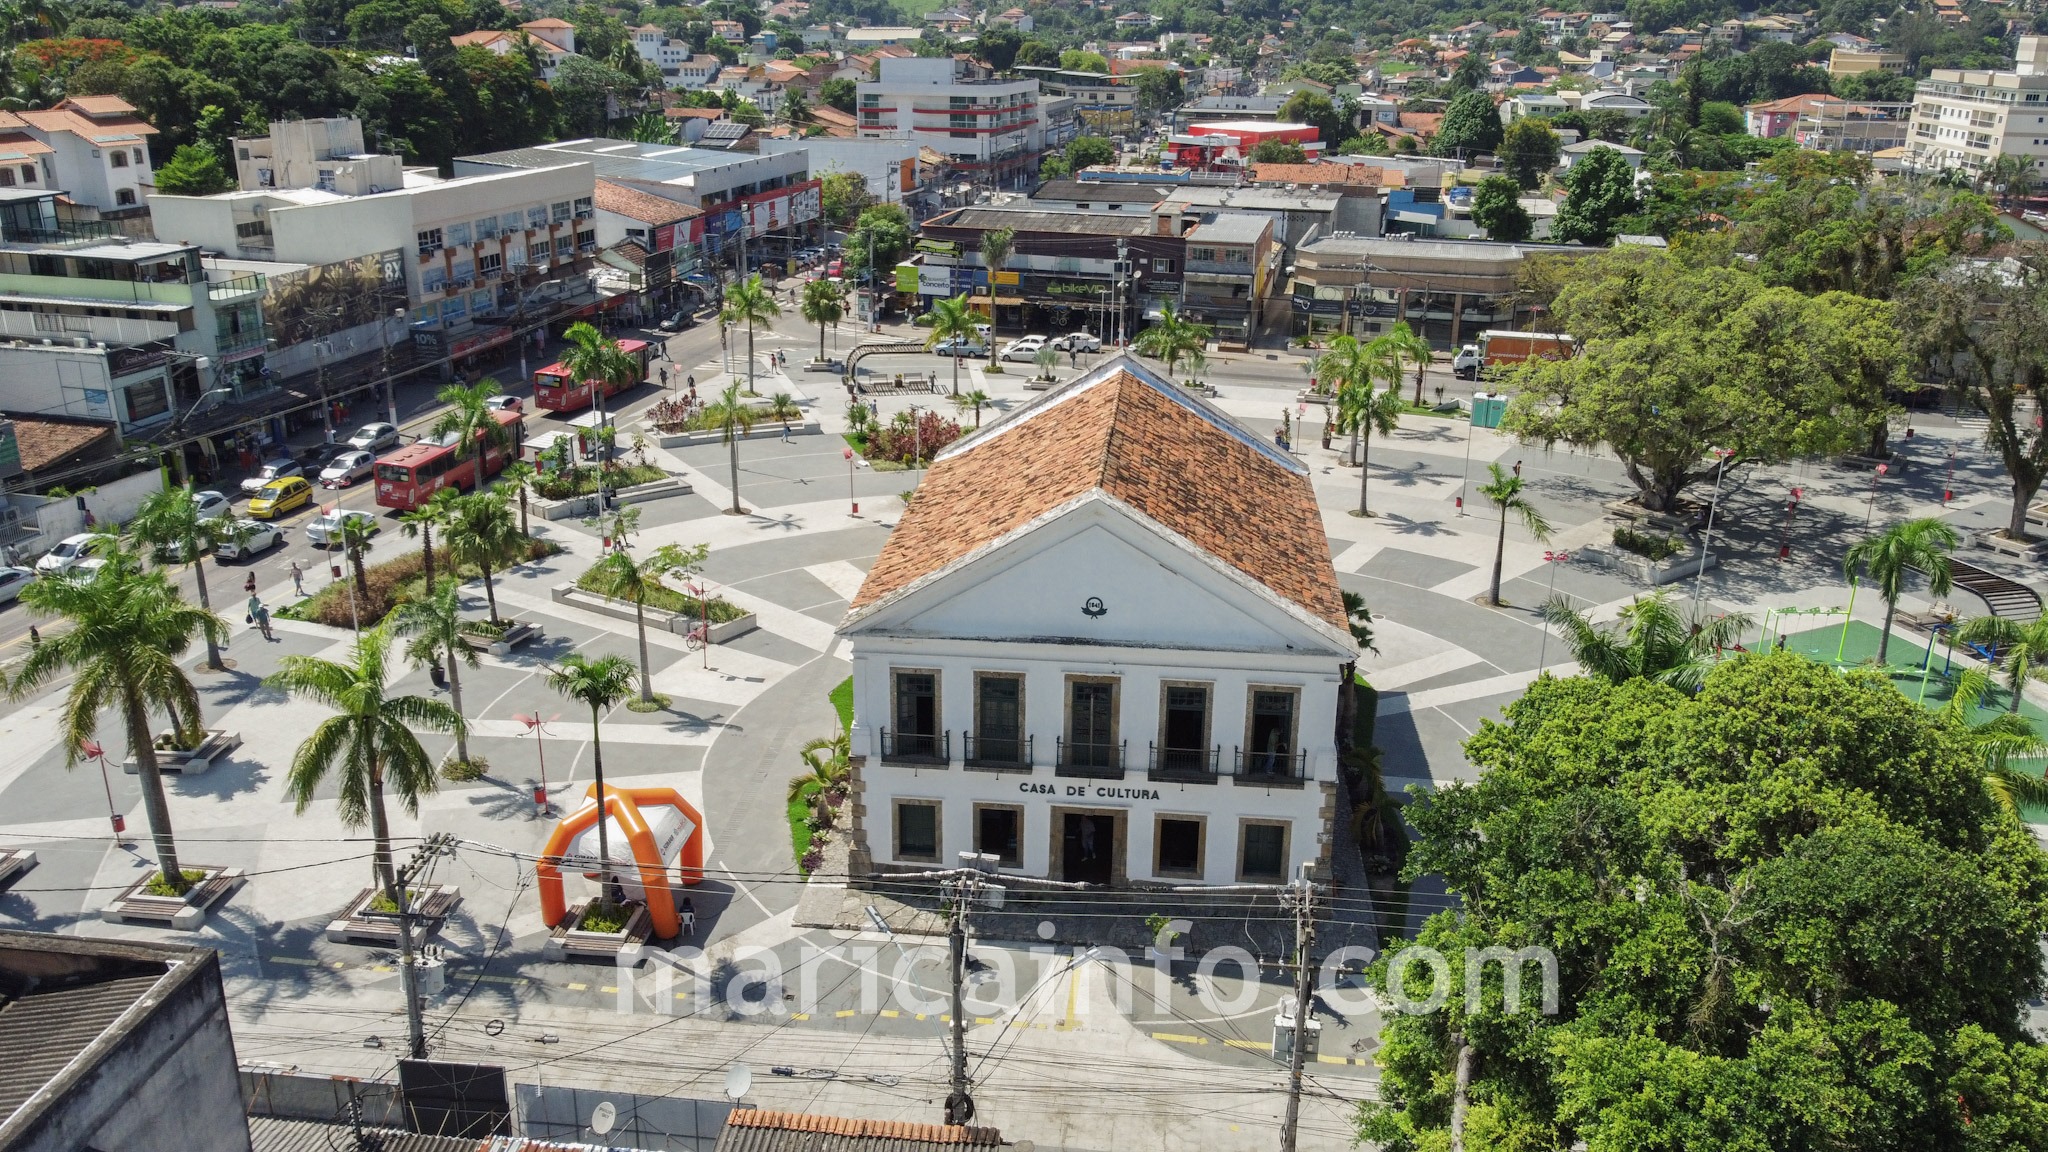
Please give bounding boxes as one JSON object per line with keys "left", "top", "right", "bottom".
{"left": 0, "top": 933, "right": 250, "bottom": 1152}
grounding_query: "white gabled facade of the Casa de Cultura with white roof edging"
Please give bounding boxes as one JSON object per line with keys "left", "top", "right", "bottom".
{"left": 840, "top": 361, "right": 1356, "bottom": 886}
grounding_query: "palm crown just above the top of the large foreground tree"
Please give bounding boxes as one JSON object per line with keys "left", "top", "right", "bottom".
{"left": 1542, "top": 588, "right": 1749, "bottom": 693}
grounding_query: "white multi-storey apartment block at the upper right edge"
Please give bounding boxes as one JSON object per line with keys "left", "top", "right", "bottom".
{"left": 1905, "top": 37, "right": 2048, "bottom": 174}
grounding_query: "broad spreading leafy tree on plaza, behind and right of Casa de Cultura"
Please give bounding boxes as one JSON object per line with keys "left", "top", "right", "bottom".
{"left": 1503, "top": 250, "right": 1890, "bottom": 512}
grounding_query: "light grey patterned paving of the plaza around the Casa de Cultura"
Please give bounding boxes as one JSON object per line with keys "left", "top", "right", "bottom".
{"left": 0, "top": 307, "right": 2048, "bottom": 1150}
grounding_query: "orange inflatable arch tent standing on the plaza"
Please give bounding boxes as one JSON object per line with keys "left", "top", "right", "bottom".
{"left": 535, "top": 785, "right": 705, "bottom": 939}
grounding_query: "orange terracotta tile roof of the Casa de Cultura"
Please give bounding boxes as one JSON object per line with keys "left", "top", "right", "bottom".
{"left": 852, "top": 359, "right": 1346, "bottom": 629}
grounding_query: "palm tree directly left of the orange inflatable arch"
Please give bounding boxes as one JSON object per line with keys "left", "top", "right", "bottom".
{"left": 264, "top": 623, "right": 465, "bottom": 893}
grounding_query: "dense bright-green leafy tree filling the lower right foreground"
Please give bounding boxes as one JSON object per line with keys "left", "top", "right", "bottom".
{"left": 1360, "top": 654, "right": 2048, "bottom": 1152}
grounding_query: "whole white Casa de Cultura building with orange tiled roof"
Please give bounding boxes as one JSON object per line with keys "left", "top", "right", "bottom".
{"left": 840, "top": 359, "right": 1358, "bottom": 883}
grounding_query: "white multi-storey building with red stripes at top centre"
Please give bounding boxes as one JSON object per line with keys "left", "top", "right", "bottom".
{"left": 854, "top": 57, "right": 1044, "bottom": 189}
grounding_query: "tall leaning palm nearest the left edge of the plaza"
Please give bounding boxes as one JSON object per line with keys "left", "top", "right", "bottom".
{"left": 6, "top": 541, "right": 227, "bottom": 892}
